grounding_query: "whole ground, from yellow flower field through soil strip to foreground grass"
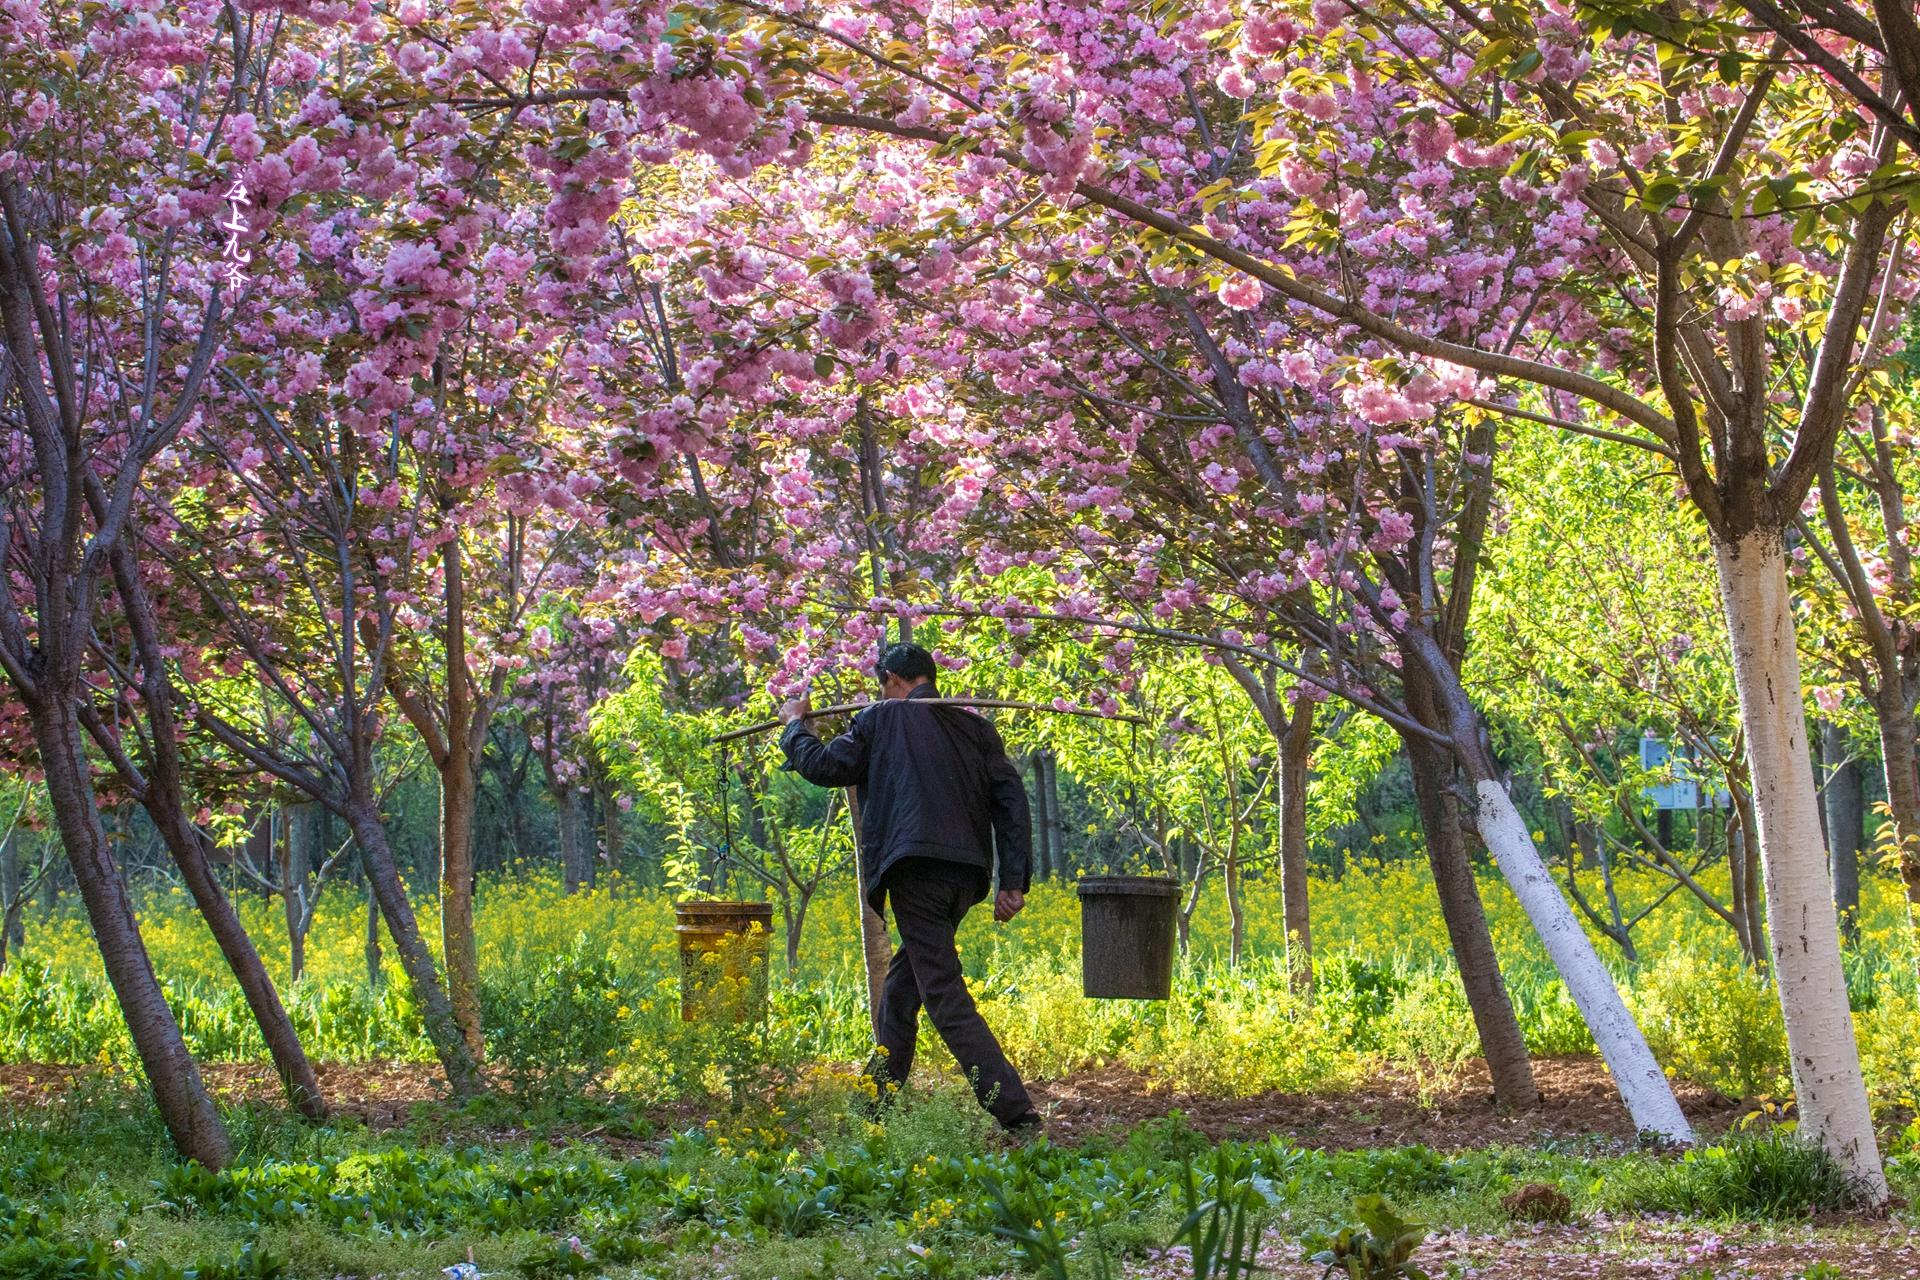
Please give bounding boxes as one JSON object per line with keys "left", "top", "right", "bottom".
{"left": 0, "top": 869, "right": 1920, "bottom": 1280}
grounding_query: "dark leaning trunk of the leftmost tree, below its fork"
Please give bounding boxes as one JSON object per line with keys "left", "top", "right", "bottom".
{"left": 31, "top": 691, "right": 232, "bottom": 1169}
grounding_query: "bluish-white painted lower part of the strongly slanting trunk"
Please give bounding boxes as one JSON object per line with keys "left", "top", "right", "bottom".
{"left": 1475, "top": 779, "right": 1697, "bottom": 1142}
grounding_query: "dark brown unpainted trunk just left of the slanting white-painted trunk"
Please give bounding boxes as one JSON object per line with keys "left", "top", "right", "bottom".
{"left": 1402, "top": 735, "right": 1540, "bottom": 1109}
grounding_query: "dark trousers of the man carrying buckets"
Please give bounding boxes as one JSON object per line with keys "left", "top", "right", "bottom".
{"left": 877, "top": 858, "right": 1033, "bottom": 1125}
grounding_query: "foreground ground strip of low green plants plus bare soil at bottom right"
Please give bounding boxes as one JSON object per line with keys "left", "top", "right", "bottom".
{"left": 0, "top": 1073, "right": 1920, "bottom": 1280}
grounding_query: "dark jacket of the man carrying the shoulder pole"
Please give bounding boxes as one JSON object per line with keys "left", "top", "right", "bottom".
{"left": 780, "top": 685, "right": 1033, "bottom": 912}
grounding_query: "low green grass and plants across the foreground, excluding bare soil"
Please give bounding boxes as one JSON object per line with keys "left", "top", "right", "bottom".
{"left": 0, "top": 1080, "right": 1920, "bottom": 1280}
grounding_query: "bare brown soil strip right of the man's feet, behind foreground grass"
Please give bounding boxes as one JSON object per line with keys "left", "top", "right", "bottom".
{"left": 1033, "top": 1057, "right": 1747, "bottom": 1150}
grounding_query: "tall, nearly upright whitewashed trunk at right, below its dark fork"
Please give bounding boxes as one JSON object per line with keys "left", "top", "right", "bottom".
{"left": 1715, "top": 532, "right": 1887, "bottom": 1203}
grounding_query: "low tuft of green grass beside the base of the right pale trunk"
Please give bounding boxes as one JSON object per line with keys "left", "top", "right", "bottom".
{"left": 1607, "top": 1126, "right": 1855, "bottom": 1219}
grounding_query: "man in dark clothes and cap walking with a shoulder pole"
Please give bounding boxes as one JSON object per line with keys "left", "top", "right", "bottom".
{"left": 780, "top": 645, "right": 1041, "bottom": 1130}
